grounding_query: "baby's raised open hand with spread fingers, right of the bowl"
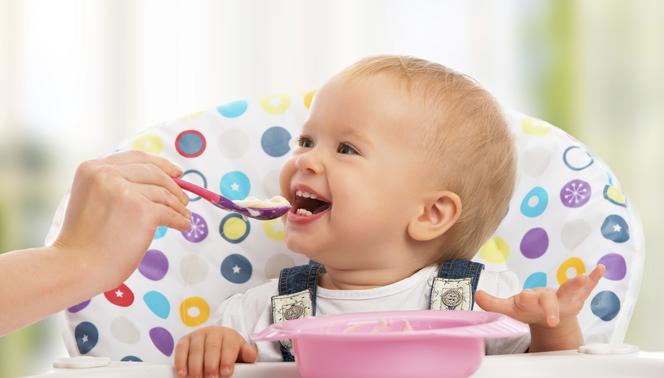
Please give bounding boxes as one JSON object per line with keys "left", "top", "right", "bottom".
{"left": 475, "top": 264, "right": 605, "bottom": 328}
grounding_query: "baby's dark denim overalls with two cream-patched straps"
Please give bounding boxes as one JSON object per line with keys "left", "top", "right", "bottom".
{"left": 272, "top": 260, "right": 484, "bottom": 362}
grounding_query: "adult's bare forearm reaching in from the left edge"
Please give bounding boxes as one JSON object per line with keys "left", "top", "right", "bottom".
{"left": 0, "top": 247, "right": 103, "bottom": 336}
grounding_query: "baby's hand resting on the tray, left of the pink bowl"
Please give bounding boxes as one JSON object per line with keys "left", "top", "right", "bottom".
{"left": 175, "top": 326, "right": 256, "bottom": 377}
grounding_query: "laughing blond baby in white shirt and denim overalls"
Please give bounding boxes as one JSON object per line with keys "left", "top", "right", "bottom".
{"left": 175, "top": 56, "right": 604, "bottom": 377}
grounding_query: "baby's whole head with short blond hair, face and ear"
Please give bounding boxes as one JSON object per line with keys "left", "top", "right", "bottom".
{"left": 280, "top": 56, "right": 516, "bottom": 271}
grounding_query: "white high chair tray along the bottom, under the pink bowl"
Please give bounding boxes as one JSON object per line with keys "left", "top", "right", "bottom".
{"left": 26, "top": 350, "right": 664, "bottom": 378}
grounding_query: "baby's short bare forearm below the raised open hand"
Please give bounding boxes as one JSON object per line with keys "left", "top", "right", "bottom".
{"left": 529, "top": 317, "right": 583, "bottom": 352}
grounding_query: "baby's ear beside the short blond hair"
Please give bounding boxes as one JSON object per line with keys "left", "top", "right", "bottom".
{"left": 408, "top": 191, "right": 461, "bottom": 241}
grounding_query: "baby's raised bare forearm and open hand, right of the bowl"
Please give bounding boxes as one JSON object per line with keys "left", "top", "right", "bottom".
{"left": 475, "top": 264, "right": 605, "bottom": 352}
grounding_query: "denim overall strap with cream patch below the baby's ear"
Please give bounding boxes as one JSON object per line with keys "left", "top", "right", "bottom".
{"left": 429, "top": 260, "right": 484, "bottom": 311}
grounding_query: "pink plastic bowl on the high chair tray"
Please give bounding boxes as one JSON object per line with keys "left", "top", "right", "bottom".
{"left": 253, "top": 311, "right": 528, "bottom": 378}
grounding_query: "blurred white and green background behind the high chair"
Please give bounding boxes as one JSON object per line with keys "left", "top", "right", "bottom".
{"left": 0, "top": 0, "right": 664, "bottom": 377}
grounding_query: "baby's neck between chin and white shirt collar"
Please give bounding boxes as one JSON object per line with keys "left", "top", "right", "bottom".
{"left": 318, "top": 266, "right": 423, "bottom": 290}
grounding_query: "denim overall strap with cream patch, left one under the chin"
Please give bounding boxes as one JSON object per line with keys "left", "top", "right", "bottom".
{"left": 272, "top": 261, "right": 324, "bottom": 362}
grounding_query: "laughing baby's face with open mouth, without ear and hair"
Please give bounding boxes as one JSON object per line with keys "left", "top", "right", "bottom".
{"left": 280, "top": 74, "right": 429, "bottom": 269}
